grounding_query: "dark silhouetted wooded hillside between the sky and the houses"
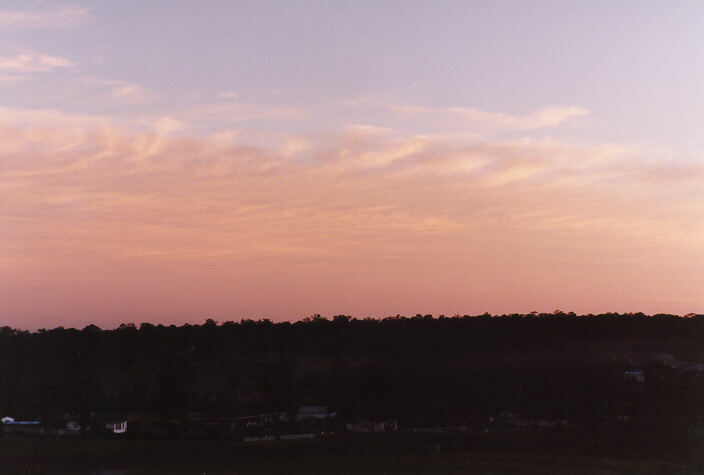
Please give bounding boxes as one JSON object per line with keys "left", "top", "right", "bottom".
{"left": 0, "top": 312, "right": 704, "bottom": 434}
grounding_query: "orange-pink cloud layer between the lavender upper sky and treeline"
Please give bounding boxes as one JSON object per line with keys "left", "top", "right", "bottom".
{"left": 0, "top": 114, "right": 704, "bottom": 328}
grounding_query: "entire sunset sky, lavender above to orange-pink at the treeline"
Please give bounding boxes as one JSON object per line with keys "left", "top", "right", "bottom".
{"left": 0, "top": 0, "right": 704, "bottom": 329}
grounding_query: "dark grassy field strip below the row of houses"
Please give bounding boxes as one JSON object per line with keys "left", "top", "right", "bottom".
{"left": 0, "top": 433, "right": 704, "bottom": 475}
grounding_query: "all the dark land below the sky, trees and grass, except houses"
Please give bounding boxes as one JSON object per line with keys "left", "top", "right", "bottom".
{"left": 0, "top": 312, "right": 704, "bottom": 473}
